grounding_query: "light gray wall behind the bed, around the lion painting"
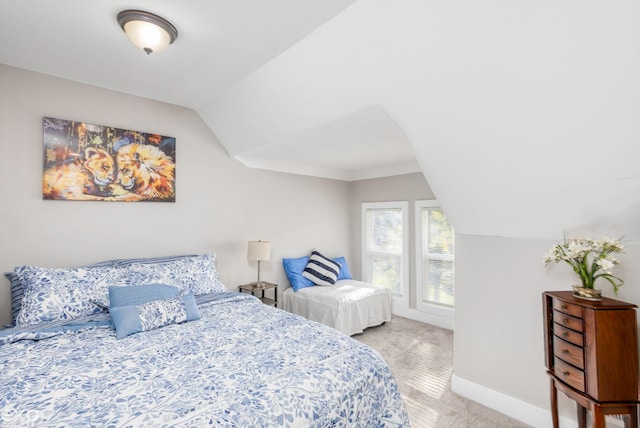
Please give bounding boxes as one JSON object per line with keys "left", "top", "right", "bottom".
{"left": 0, "top": 65, "right": 351, "bottom": 323}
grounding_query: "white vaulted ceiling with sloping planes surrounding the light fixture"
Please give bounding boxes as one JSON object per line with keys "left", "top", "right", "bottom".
{"left": 0, "top": 0, "right": 640, "bottom": 238}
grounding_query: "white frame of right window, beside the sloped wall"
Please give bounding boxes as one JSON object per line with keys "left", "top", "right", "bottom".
{"left": 414, "top": 199, "right": 455, "bottom": 320}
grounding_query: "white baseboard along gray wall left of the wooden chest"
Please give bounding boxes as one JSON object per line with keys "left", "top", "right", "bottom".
{"left": 451, "top": 373, "right": 578, "bottom": 428}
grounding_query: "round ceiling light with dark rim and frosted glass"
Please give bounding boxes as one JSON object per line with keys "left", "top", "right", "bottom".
{"left": 118, "top": 10, "right": 178, "bottom": 55}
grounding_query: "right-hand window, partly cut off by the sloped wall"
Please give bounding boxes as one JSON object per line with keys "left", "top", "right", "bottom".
{"left": 416, "top": 201, "right": 454, "bottom": 315}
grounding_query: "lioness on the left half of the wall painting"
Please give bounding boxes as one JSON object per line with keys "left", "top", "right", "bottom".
{"left": 42, "top": 147, "right": 116, "bottom": 201}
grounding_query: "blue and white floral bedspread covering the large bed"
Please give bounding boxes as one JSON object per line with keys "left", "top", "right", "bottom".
{"left": 0, "top": 292, "right": 409, "bottom": 428}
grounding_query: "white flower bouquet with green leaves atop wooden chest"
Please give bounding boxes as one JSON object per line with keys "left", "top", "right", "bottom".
{"left": 544, "top": 238, "right": 624, "bottom": 296}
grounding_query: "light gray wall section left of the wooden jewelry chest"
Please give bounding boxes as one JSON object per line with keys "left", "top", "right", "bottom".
{"left": 454, "top": 234, "right": 552, "bottom": 407}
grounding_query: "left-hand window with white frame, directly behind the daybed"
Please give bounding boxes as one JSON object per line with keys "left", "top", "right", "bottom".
{"left": 362, "top": 202, "right": 409, "bottom": 307}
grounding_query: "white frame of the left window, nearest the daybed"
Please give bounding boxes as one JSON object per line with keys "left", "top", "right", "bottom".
{"left": 361, "top": 201, "right": 411, "bottom": 308}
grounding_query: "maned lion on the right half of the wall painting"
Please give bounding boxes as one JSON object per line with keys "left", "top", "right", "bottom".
{"left": 112, "top": 143, "right": 176, "bottom": 202}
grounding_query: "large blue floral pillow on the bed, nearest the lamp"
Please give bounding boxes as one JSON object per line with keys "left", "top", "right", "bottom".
{"left": 127, "top": 252, "right": 227, "bottom": 296}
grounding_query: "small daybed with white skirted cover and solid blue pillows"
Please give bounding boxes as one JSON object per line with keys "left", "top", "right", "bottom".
{"left": 282, "top": 253, "right": 392, "bottom": 336}
